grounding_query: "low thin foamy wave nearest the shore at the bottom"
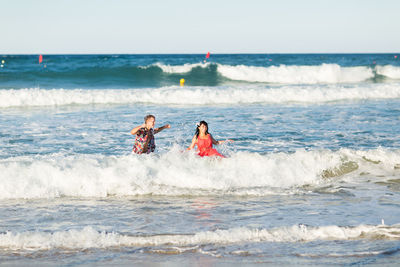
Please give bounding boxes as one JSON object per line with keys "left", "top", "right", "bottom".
{"left": 0, "top": 225, "right": 400, "bottom": 250}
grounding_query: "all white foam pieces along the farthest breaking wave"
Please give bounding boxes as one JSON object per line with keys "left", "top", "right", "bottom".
{"left": 156, "top": 63, "right": 400, "bottom": 84}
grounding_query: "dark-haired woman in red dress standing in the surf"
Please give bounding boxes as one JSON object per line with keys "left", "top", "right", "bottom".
{"left": 187, "top": 121, "right": 233, "bottom": 158}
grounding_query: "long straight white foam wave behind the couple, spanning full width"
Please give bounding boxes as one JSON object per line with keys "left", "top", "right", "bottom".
{"left": 0, "top": 83, "right": 400, "bottom": 108}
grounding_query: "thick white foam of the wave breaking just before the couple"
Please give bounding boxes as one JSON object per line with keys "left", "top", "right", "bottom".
{"left": 0, "top": 150, "right": 325, "bottom": 198}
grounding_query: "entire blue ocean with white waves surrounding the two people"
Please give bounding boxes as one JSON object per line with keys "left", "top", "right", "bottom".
{"left": 0, "top": 53, "right": 400, "bottom": 266}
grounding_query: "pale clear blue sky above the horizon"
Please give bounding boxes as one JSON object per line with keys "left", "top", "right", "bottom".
{"left": 0, "top": 0, "right": 400, "bottom": 54}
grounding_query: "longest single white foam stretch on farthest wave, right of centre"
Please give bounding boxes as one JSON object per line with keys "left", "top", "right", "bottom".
{"left": 218, "top": 64, "right": 374, "bottom": 84}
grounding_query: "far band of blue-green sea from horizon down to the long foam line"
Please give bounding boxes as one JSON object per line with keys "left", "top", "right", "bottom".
{"left": 0, "top": 54, "right": 400, "bottom": 89}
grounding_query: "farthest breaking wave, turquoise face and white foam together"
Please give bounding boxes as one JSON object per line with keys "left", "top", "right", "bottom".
{"left": 4, "top": 63, "right": 400, "bottom": 89}
